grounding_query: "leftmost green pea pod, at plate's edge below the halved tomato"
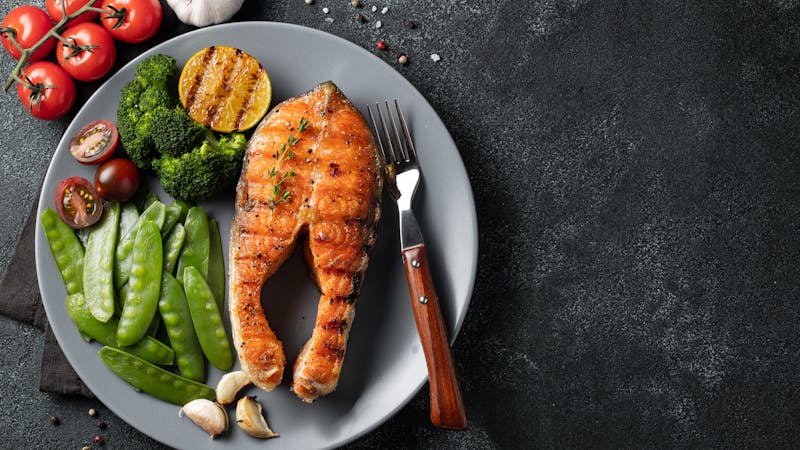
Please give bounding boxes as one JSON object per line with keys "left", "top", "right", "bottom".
{"left": 41, "top": 208, "right": 84, "bottom": 294}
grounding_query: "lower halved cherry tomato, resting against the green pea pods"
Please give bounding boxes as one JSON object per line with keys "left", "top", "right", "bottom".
{"left": 55, "top": 177, "right": 103, "bottom": 228}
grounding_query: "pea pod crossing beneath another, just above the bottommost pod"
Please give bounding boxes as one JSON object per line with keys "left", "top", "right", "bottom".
{"left": 67, "top": 294, "right": 175, "bottom": 365}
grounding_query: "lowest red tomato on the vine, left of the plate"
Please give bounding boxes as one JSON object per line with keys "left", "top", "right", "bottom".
{"left": 17, "top": 61, "right": 75, "bottom": 120}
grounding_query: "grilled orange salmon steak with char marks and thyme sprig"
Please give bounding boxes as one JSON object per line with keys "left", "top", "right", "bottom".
{"left": 229, "top": 81, "right": 382, "bottom": 403}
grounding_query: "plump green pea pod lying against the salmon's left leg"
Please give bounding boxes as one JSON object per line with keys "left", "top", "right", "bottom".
{"left": 183, "top": 266, "right": 233, "bottom": 371}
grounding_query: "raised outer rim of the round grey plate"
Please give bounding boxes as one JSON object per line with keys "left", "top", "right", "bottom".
{"left": 34, "top": 21, "right": 480, "bottom": 449}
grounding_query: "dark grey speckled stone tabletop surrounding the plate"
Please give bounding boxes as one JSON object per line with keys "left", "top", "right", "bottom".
{"left": 0, "top": 0, "right": 800, "bottom": 448}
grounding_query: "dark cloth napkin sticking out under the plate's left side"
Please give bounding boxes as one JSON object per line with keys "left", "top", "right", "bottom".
{"left": 0, "top": 201, "right": 94, "bottom": 397}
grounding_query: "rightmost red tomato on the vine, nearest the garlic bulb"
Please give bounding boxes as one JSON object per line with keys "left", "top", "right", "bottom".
{"left": 100, "top": 0, "right": 163, "bottom": 44}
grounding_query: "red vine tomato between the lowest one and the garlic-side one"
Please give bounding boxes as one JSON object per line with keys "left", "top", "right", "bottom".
{"left": 56, "top": 23, "right": 117, "bottom": 81}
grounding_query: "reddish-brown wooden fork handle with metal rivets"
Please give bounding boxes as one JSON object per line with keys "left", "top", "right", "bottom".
{"left": 403, "top": 244, "right": 467, "bottom": 430}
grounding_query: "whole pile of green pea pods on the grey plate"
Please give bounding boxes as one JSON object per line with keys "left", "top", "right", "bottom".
{"left": 41, "top": 193, "right": 233, "bottom": 405}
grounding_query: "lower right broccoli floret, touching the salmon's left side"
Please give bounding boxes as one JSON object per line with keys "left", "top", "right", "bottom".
{"left": 153, "top": 133, "right": 246, "bottom": 200}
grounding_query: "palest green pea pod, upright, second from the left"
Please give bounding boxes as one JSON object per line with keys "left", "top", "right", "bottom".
{"left": 83, "top": 202, "right": 120, "bottom": 322}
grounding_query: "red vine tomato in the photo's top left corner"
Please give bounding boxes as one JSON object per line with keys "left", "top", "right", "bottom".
{"left": 0, "top": 6, "right": 56, "bottom": 61}
